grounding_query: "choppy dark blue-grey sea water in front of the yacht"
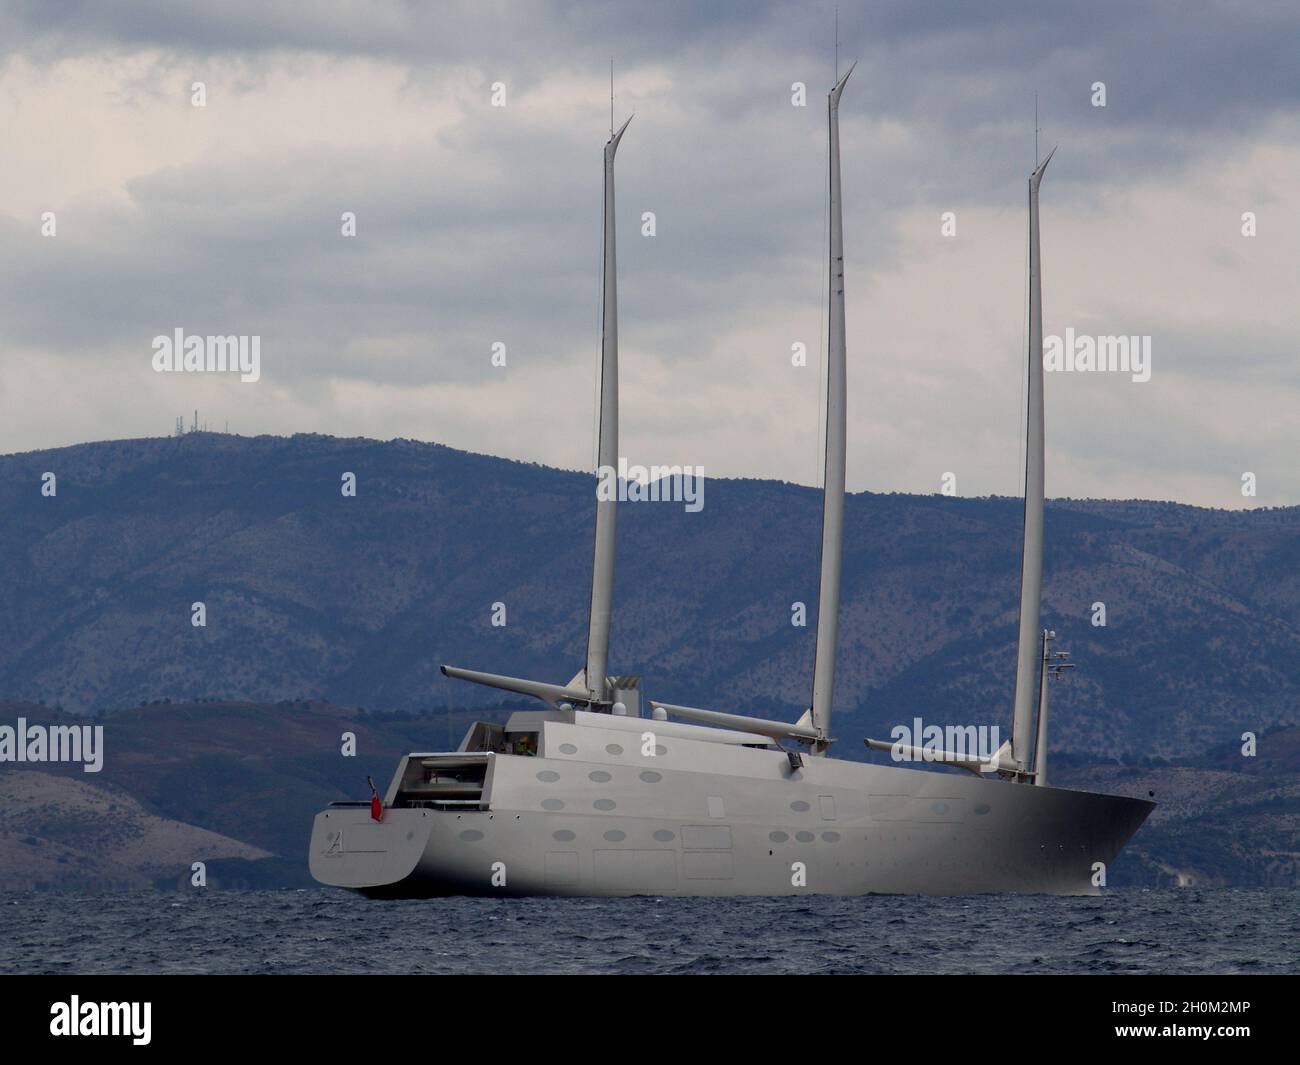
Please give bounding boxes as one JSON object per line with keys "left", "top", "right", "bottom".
{"left": 0, "top": 889, "right": 1300, "bottom": 974}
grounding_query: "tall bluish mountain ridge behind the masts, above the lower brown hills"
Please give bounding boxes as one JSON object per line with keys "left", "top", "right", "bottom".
{"left": 0, "top": 433, "right": 1300, "bottom": 759}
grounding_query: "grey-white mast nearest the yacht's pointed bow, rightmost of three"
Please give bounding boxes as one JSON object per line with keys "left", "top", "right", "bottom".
{"left": 1011, "top": 148, "right": 1056, "bottom": 771}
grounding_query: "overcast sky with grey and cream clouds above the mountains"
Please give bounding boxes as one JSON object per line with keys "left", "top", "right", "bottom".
{"left": 0, "top": 0, "right": 1300, "bottom": 506}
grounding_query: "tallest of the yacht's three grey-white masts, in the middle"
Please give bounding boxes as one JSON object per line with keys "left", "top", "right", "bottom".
{"left": 813, "top": 64, "right": 857, "bottom": 754}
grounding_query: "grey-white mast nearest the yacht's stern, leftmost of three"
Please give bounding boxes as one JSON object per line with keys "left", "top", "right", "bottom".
{"left": 585, "top": 118, "right": 632, "bottom": 702}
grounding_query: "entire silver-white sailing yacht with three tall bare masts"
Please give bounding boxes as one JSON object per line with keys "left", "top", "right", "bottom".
{"left": 309, "top": 68, "right": 1154, "bottom": 897}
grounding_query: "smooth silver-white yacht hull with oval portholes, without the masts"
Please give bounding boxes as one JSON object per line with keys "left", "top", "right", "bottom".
{"left": 311, "top": 713, "right": 1154, "bottom": 897}
